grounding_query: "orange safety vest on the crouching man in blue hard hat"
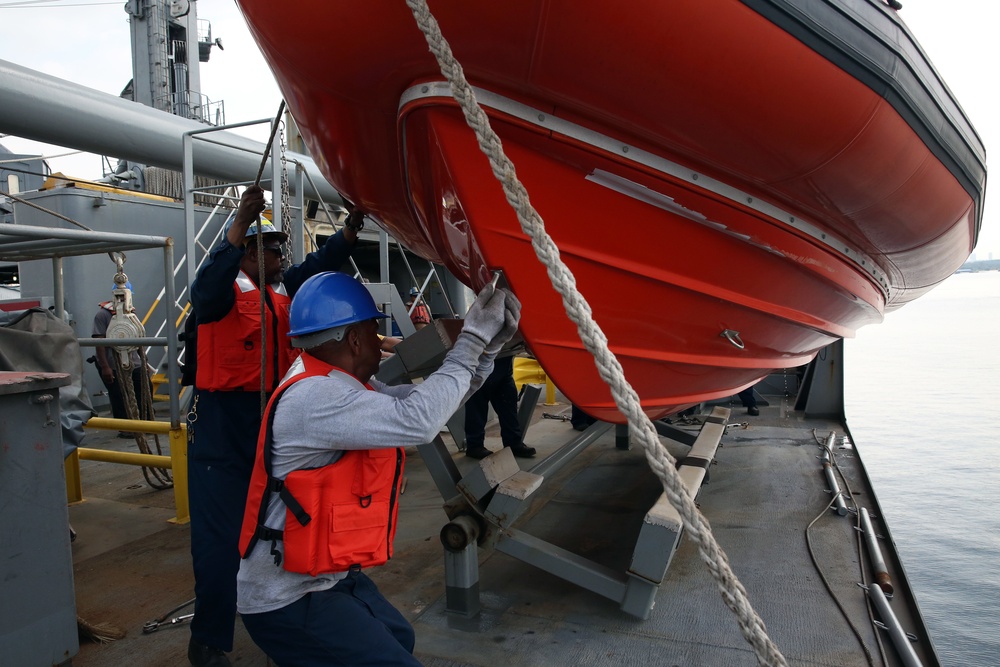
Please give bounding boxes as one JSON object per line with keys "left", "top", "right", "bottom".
{"left": 240, "top": 353, "right": 406, "bottom": 577}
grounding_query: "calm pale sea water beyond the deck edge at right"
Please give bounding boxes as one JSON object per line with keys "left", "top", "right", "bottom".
{"left": 845, "top": 272, "right": 1000, "bottom": 667}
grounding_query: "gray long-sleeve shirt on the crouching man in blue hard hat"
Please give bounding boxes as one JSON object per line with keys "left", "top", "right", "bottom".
{"left": 236, "top": 334, "right": 493, "bottom": 614}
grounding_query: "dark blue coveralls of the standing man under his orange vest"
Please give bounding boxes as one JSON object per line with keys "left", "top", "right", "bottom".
{"left": 188, "top": 231, "right": 354, "bottom": 651}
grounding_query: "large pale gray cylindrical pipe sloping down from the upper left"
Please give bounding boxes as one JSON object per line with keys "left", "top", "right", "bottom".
{"left": 0, "top": 60, "right": 342, "bottom": 205}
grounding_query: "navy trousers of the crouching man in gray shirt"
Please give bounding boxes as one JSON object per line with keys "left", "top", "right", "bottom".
{"left": 243, "top": 572, "right": 420, "bottom": 667}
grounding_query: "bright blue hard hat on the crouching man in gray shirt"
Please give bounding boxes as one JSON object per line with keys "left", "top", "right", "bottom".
{"left": 288, "top": 271, "right": 388, "bottom": 338}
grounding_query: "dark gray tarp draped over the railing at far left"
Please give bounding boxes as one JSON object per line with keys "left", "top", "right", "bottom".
{"left": 0, "top": 308, "right": 97, "bottom": 456}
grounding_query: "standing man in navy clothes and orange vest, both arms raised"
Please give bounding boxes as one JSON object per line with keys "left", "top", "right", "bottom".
{"left": 188, "top": 186, "right": 363, "bottom": 667}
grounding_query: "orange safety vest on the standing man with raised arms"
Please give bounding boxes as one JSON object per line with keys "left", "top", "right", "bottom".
{"left": 195, "top": 271, "right": 299, "bottom": 391}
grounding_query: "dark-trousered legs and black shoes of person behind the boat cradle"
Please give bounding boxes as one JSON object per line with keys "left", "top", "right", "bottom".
{"left": 465, "top": 356, "right": 535, "bottom": 459}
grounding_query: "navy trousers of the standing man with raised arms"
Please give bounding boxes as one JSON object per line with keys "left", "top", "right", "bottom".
{"left": 188, "top": 391, "right": 260, "bottom": 651}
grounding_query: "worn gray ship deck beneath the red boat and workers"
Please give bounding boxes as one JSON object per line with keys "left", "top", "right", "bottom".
{"left": 69, "top": 384, "right": 937, "bottom": 667}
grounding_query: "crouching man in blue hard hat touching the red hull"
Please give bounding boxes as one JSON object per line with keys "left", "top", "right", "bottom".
{"left": 237, "top": 273, "right": 521, "bottom": 665}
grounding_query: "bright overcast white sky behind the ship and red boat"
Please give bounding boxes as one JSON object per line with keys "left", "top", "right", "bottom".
{"left": 0, "top": 0, "right": 1000, "bottom": 259}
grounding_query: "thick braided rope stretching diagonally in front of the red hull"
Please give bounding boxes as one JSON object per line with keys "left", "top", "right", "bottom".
{"left": 406, "top": 0, "right": 787, "bottom": 666}
